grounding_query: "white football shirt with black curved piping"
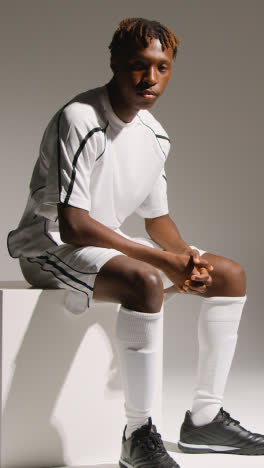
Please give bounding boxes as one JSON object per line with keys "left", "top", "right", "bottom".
{"left": 8, "top": 86, "right": 170, "bottom": 257}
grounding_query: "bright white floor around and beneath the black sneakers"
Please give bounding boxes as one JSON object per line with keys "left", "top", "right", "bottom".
{"left": 51, "top": 371, "right": 264, "bottom": 468}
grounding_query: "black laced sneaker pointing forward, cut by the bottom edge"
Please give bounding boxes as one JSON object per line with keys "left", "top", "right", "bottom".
{"left": 119, "top": 418, "right": 180, "bottom": 468}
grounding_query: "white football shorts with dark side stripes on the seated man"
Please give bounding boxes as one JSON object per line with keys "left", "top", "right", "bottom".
{"left": 20, "top": 229, "right": 206, "bottom": 307}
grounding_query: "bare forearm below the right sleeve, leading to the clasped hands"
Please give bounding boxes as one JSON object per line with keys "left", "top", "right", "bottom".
{"left": 145, "top": 215, "right": 191, "bottom": 254}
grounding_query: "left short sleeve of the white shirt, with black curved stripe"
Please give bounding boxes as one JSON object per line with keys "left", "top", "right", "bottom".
{"left": 41, "top": 106, "right": 101, "bottom": 214}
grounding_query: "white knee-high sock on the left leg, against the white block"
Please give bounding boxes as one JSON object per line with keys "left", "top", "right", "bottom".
{"left": 116, "top": 306, "right": 163, "bottom": 438}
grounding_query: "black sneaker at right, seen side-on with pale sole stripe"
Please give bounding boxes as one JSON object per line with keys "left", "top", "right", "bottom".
{"left": 178, "top": 408, "right": 264, "bottom": 455}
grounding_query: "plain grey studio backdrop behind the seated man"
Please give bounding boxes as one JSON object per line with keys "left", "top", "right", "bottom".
{"left": 0, "top": 0, "right": 264, "bottom": 380}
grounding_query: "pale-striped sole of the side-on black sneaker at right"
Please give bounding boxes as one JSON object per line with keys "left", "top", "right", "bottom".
{"left": 178, "top": 441, "right": 264, "bottom": 456}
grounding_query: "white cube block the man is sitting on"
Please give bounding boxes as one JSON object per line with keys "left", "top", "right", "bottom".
{"left": 0, "top": 282, "right": 162, "bottom": 468}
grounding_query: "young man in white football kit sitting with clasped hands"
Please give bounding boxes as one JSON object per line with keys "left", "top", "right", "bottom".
{"left": 8, "top": 18, "right": 264, "bottom": 468}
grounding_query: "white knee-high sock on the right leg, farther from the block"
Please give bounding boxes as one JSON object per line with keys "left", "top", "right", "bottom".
{"left": 192, "top": 296, "right": 246, "bottom": 426}
